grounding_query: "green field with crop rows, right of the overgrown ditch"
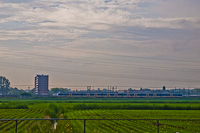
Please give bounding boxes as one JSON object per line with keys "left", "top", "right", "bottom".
{"left": 67, "top": 110, "right": 200, "bottom": 133}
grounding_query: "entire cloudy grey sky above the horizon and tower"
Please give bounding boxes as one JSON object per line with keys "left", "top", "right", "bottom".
{"left": 0, "top": 0, "right": 200, "bottom": 89}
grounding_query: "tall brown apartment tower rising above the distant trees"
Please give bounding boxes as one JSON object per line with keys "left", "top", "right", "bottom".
{"left": 35, "top": 75, "right": 49, "bottom": 95}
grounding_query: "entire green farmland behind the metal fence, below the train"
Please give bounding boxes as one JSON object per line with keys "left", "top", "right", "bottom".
{"left": 0, "top": 98, "right": 200, "bottom": 133}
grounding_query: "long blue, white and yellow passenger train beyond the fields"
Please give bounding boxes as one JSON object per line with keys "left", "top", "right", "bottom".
{"left": 57, "top": 93, "right": 183, "bottom": 97}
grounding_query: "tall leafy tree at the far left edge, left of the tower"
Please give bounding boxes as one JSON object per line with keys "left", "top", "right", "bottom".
{"left": 0, "top": 76, "right": 10, "bottom": 95}
